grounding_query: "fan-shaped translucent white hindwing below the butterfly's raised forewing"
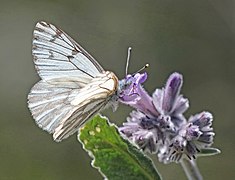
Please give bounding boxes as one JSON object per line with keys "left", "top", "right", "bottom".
{"left": 28, "top": 80, "right": 78, "bottom": 133}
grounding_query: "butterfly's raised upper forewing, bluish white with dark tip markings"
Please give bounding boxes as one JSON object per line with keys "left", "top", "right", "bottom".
{"left": 32, "top": 22, "right": 103, "bottom": 87}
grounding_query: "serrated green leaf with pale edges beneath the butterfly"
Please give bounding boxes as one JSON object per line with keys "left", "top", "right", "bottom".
{"left": 78, "top": 115, "right": 161, "bottom": 180}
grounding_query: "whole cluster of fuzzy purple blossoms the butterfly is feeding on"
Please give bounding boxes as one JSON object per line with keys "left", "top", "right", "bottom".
{"left": 119, "top": 73, "right": 214, "bottom": 163}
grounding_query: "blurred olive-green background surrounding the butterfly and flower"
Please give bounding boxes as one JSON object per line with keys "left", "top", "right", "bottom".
{"left": 0, "top": 0, "right": 235, "bottom": 180}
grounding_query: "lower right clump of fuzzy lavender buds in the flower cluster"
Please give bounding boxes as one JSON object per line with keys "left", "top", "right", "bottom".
{"left": 162, "top": 112, "right": 215, "bottom": 161}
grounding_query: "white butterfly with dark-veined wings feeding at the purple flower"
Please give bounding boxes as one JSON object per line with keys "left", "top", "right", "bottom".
{"left": 28, "top": 22, "right": 121, "bottom": 141}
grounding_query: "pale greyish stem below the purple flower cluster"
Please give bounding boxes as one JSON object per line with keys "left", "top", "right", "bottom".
{"left": 180, "top": 158, "right": 203, "bottom": 180}
